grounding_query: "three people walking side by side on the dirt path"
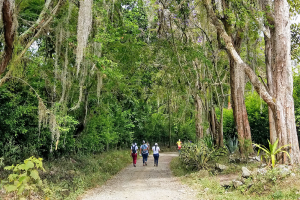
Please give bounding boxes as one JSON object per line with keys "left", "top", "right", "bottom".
{"left": 130, "top": 141, "right": 160, "bottom": 167}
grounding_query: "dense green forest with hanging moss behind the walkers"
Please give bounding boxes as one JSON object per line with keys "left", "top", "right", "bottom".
{"left": 0, "top": 0, "right": 300, "bottom": 166}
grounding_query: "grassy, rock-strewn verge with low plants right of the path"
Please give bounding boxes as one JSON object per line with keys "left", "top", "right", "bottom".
{"left": 170, "top": 143, "right": 300, "bottom": 200}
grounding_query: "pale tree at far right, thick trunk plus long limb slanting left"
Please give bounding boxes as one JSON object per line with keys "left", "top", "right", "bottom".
{"left": 203, "top": 0, "right": 300, "bottom": 163}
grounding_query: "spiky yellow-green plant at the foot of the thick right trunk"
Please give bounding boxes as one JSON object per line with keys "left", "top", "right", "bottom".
{"left": 254, "top": 139, "right": 291, "bottom": 168}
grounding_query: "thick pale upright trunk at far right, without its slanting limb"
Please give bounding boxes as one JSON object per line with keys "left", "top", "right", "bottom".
{"left": 272, "top": 0, "right": 300, "bottom": 163}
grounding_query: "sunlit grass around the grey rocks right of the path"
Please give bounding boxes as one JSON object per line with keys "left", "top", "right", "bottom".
{"left": 170, "top": 157, "right": 300, "bottom": 200}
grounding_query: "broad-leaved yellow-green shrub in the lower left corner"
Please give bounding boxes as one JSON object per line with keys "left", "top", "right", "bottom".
{"left": 4, "top": 157, "right": 45, "bottom": 199}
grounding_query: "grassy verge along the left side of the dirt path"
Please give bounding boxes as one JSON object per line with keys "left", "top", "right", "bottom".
{"left": 0, "top": 151, "right": 132, "bottom": 200}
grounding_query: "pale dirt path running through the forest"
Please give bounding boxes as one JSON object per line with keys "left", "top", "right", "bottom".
{"left": 80, "top": 153, "right": 196, "bottom": 200}
